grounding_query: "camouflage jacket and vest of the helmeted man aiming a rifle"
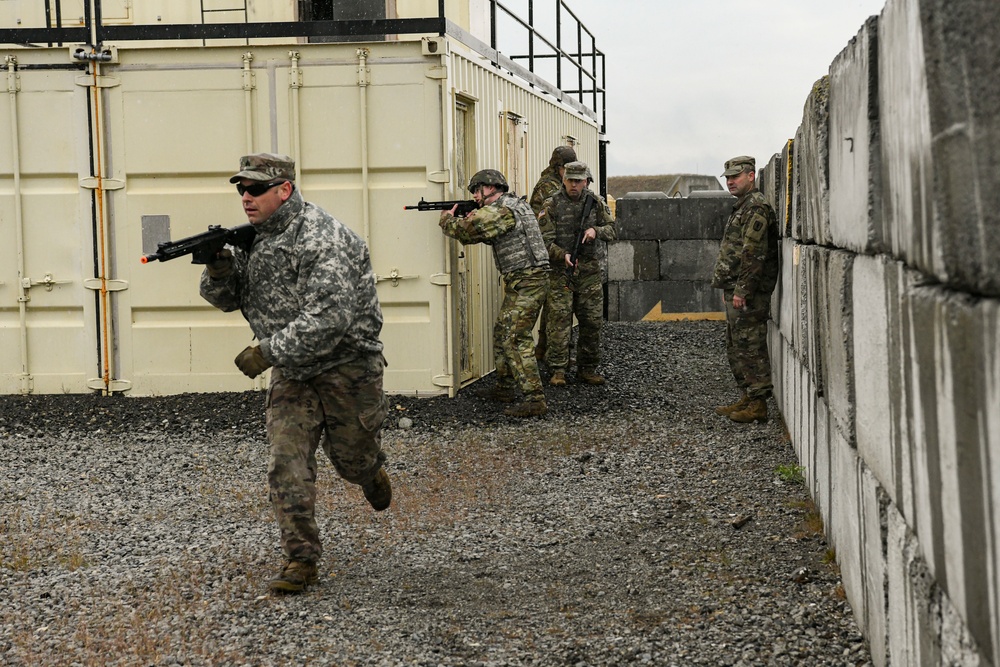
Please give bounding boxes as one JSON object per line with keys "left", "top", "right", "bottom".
{"left": 440, "top": 192, "right": 549, "bottom": 273}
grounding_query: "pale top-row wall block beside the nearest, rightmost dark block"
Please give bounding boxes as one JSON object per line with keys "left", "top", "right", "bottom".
{"left": 830, "top": 16, "right": 889, "bottom": 253}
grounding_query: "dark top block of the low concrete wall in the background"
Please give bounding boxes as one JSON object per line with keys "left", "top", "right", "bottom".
{"left": 617, "top": 195, "right": 735, "bottom": 240}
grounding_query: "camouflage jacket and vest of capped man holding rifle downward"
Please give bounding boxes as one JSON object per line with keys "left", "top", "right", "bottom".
{"left": 538, "top": 188, "right": 618, "bottom": 268}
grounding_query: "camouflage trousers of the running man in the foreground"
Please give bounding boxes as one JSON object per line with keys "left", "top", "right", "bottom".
{"left": 267, "top": 354, "right": 389, "bottom": 562}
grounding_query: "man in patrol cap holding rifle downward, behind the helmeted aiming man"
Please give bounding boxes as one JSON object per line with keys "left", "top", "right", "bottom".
{"left": 538, "top": 162, "right": 618, "bottom": 386}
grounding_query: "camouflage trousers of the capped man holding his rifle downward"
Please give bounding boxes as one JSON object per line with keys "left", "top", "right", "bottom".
{"left": 545, "top": 259, "right": 604, "bottom": 371}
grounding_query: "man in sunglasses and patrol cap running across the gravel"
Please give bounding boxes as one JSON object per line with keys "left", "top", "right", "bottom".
{"left": 201, "top": 153, "right": 392, "bottom": 593}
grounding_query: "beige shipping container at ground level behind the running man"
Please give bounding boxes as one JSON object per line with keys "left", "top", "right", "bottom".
{"left": 0, "top": 5, "right": 600, "bottom": 396}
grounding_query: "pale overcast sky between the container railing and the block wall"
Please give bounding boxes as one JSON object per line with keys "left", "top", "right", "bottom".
{"left": 516, "top": 0, "right": 885, "bottom": 176}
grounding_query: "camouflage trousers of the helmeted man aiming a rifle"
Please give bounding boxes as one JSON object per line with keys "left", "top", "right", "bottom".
{"left": 493, "top": 267, "right": 549, "bottom": 400}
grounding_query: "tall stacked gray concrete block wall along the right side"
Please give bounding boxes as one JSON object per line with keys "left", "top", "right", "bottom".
{"left": 758, "top": 0, "right": 1000, "bottom": 665}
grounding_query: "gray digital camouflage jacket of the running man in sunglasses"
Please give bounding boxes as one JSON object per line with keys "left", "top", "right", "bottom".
{"left": 201, "top": 188, "right": 382, "bottom": 380}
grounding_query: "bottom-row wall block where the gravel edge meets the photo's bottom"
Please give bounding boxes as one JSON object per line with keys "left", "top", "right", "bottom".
{"left": 852, "top": 461, "right": 891, "bottom": 667}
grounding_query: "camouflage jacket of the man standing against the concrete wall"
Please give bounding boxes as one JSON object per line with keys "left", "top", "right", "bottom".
{"left": 712, "top": 190, "right": 778, "bottom": 298}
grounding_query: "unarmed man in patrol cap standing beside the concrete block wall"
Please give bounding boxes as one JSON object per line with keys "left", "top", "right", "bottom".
{"left": 712, "top": 155, "right": 778, "bottom": 423}
